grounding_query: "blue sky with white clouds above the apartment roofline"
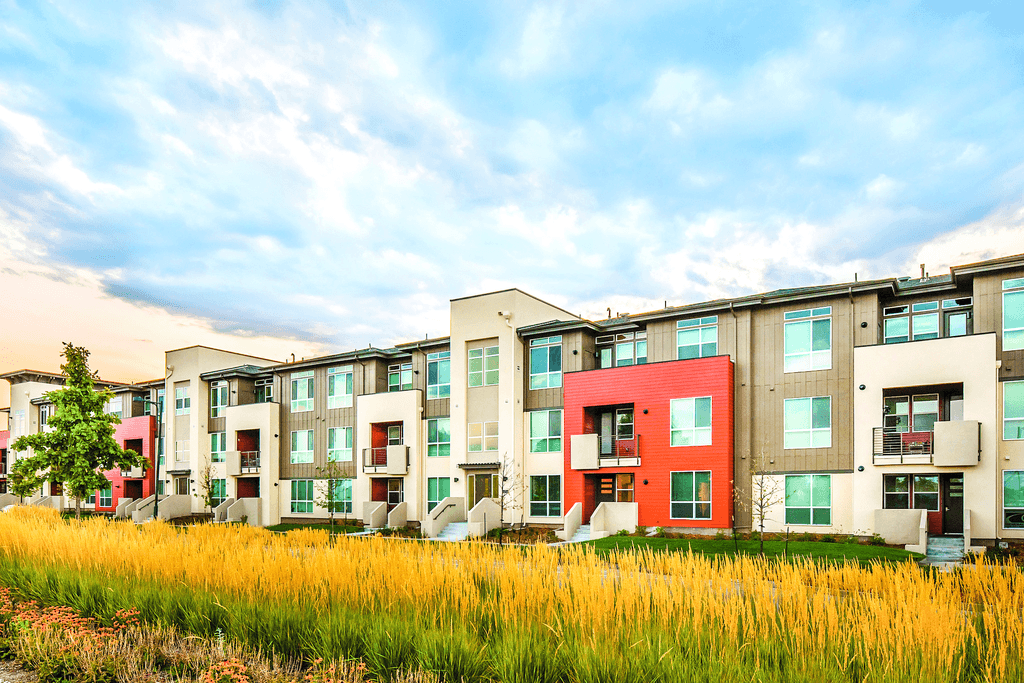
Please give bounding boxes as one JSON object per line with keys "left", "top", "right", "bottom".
{"left": 6, "top": 0, "right": 1024, "bottom": 405}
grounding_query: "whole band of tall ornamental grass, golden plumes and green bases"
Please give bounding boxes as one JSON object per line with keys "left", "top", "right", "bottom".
{"left": 0, "top": 508, "right": 1024, "bottom": 683}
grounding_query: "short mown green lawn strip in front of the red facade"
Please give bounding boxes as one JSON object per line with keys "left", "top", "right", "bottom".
{"left": 587, "top": 536, "right": 922, "bottom": 564}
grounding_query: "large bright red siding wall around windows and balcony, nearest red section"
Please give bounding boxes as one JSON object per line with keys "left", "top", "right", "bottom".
{"left": 563, "top": 355, "right": 734, "bottom": 528}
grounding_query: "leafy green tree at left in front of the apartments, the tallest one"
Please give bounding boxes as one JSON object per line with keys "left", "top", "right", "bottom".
{"left": 11, "top": 343, "right": 145, "bottom": 517}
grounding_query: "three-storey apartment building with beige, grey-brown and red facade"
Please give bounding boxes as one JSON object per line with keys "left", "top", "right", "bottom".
{"left": 0, "top": 255, "right": 1024, "bottom": 546}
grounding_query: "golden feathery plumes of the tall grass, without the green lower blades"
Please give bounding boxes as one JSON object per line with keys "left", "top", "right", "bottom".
{"left": 0, "top": 508, "right": 1024, "bottom": 680}
